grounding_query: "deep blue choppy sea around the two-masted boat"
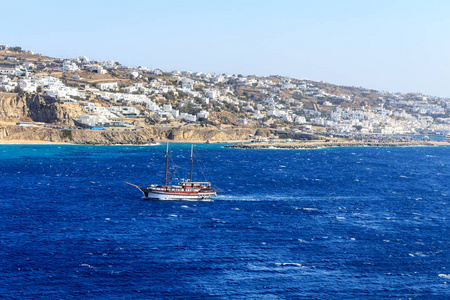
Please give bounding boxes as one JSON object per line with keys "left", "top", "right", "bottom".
{"left": 0, "top": 144, "right": 450, "bottom": 299}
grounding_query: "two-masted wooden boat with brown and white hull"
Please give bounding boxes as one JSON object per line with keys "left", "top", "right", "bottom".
{"left": 126, "top": 142, "right": 217, "bottom": 200}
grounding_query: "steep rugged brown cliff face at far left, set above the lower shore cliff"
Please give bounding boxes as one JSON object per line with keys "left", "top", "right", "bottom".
{"left": 0, "top": 93, "right": 82, "bottom": 125}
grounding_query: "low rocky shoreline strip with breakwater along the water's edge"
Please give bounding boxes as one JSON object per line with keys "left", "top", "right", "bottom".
{"left": 0, "top": 125, "right": 449, "bottom": 149}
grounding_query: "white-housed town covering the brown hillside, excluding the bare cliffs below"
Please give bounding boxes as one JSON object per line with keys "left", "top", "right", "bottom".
{"left": 0, "top": 45, "right": 450, "bottom": 142}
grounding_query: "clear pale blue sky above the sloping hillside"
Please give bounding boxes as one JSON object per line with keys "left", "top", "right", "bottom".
{"left": 0, "top": 0, "right": 450, "bottom": 97}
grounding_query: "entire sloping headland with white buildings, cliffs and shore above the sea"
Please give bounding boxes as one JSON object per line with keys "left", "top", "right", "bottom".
{"left": 0, "top": 45, "right": 450, "bottom": 148}
